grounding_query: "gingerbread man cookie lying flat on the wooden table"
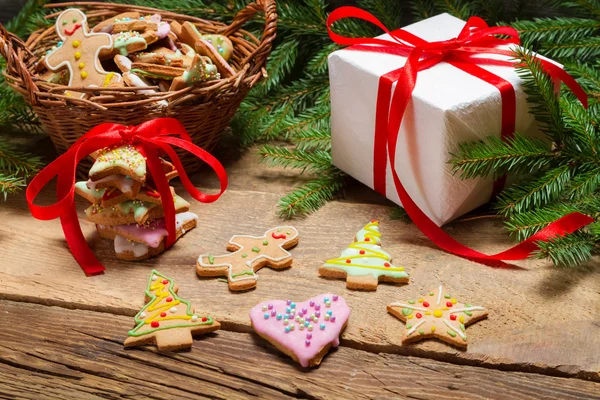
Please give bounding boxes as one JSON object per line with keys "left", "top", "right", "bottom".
{"left": 196, "top": 226, "right": 299, "bottom": 290}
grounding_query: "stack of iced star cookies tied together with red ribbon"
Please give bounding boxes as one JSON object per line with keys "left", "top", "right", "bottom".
{"left": 75, "top": 145, "right": 198, "bottom": 261}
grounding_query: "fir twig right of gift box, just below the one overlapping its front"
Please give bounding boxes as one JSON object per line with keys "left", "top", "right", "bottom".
{"left": 497, "top": 164, "right": 571, "bottom": 216}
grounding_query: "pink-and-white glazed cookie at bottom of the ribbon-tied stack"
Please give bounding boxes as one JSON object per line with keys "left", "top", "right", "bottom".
{"left": 96, "top": 212, "right": 198, "bottom": 261}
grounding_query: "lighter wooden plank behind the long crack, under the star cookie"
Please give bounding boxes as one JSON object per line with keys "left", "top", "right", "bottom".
{"left": 0, "top": 142, "right": 600, "bottom": 380}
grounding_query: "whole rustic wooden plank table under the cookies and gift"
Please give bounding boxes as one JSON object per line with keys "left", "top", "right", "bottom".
{"left": 0, "top": 139, "right": 600, "bottom": 399}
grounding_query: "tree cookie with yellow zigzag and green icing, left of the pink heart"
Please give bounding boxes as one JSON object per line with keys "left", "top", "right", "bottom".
{"left": 124, "top": 271, "right": 221, "bottom": 351}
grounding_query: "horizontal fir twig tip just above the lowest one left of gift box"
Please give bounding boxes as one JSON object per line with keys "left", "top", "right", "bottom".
{"left": 259, "top": 144, "right": 332, "bottom": 173}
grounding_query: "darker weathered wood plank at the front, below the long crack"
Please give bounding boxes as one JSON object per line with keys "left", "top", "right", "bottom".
{"left": 0, "top": 301, "right": 600, "bottom": 400}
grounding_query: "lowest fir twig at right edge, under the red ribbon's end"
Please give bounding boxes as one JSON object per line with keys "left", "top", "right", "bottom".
{"left": 534, "top": 232, "right": 598, "bottom": 267}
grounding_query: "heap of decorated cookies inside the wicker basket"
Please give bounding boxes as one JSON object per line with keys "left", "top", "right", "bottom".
{"left": 36, "top": 9, "right": 235, "bottom": 99}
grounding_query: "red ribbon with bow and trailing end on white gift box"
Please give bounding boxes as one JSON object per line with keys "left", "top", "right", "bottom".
{"left": 327, "top": 7, "right": 594, "bottom": 264}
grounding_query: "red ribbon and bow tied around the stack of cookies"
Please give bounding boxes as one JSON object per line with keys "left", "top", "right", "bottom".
{"left": 26, "top": 118, "right": 227, "bottom": 276}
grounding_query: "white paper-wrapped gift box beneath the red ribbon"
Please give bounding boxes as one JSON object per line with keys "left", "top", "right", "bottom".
{"left": 329, "top": 14, "right": 540, "bottom": 225}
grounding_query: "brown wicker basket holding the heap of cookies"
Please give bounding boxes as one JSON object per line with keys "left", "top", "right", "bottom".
{"left": 0, "top": 0, "right": 277, "bottom": 172}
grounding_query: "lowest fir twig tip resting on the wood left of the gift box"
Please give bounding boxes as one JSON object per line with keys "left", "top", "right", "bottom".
{"left": 278, "top": 171, "right": 344, "bottom": 219}
